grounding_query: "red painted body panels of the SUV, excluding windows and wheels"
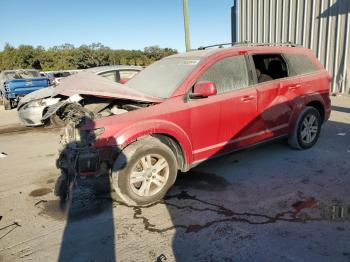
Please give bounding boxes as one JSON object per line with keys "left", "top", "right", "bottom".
{"left": 82, "top": 46, "right": 330, "bottom": 170}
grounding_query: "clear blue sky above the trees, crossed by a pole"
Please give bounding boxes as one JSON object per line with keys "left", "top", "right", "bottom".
{"left": 0, "top": 0, "right": 233, "bottom": 52}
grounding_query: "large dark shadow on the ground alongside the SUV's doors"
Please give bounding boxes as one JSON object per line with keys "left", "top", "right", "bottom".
{"left": 167, "top": 121, "right": 350, "bottom": 261}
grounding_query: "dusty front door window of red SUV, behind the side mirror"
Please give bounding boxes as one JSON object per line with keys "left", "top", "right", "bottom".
{"left": 198, "top": 56, "right": 249, "bottom": 94}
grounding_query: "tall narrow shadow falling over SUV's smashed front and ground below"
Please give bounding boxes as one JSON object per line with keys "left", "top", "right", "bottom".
{"left": 56, "top": 119, "right": 123, "bottom": 261}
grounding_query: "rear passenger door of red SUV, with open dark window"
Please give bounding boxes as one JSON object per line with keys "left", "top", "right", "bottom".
{"left": 251, "top": 54, "right": 300, "bottom": 137}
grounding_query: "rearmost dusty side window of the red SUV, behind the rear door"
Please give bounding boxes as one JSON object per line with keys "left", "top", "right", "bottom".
{"left": 285, "top": 54, "right": 317, "bottom": 76}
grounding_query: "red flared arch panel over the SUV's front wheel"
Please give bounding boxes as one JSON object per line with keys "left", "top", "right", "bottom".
{"left": 107, "top": 120, "right": 192, "bottom": 164}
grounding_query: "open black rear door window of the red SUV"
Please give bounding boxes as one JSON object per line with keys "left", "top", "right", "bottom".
{"left": 252, "top": 54, "right": 289, "bottom": 83}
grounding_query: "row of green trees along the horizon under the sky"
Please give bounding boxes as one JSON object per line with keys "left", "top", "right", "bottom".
{"left": 0, "top": 43, "right": 177, "bottom": 71}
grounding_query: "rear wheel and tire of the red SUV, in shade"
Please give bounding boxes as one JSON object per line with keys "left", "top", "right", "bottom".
{"left": 288, "top": 106, "right": 322, "bottom": 150}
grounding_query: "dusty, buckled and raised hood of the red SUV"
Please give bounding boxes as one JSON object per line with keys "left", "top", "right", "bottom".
{"left": 53, "top": 71, "right": 163, "bottom": 102}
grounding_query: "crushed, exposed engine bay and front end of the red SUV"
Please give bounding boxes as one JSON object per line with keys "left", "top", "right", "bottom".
{"left": 55, "top": 95, "right": 153, "bottom": 198}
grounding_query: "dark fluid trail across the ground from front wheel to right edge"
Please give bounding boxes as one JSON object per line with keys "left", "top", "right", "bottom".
{"left": 133, "top": 191, "right": 350, "bottom": 233}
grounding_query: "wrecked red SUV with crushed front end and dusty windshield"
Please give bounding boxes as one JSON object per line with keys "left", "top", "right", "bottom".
{"left": 56, "top": 44, "right": 331, "bottom": 205}
